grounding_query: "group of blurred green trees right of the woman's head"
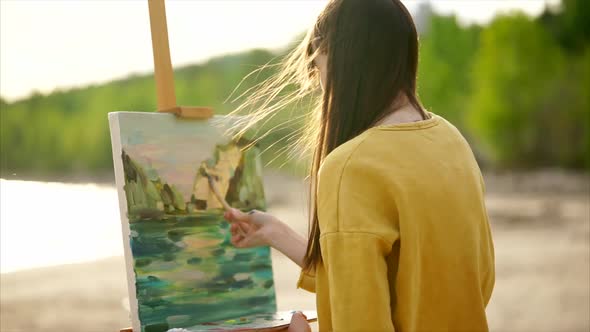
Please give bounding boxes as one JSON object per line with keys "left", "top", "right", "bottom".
{"left": 419, "top": 0, "right": 590, "bottom": 169}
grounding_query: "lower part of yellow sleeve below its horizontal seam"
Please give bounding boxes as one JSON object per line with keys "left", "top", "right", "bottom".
{"left": 320, "top": 232, "right": 394, "bottom": 332}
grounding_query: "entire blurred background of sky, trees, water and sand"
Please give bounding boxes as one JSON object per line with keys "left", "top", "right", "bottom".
{"left": 0, "top": 0, "right": 590, "bottom": 332}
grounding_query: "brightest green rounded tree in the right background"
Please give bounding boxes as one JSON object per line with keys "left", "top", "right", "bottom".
{"left": 468, "top": 14, "right": 567, "bottom": 166}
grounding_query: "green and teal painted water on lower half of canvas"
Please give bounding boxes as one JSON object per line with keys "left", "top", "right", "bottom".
{"left": 130, "top": 211, "right": 276, "bottom": 331}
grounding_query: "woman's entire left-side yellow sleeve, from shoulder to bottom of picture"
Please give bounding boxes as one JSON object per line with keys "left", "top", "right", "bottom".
{"left": 317, "top": 132, "right": 399, "bottom": 332}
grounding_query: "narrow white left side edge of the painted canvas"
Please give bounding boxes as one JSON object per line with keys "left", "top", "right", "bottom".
{"left": 108, "top": 112, "right": 141, "bottom": 332}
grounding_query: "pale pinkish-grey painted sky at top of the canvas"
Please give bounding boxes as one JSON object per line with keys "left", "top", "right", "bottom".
{"left": 119, "top": 112, "right": 236, "bottom": 200}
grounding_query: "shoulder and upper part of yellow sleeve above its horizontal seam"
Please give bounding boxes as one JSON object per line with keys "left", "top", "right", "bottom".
{"left": 316, "top": 131, "right": 396, "bottom": 239}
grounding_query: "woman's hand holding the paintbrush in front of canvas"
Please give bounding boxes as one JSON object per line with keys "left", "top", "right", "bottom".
{"left": 223, "top": 209, "right": 284, "bottom": 248}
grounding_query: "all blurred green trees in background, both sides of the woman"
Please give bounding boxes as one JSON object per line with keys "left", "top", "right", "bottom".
{"left": 0, "top": 4, "right": 590, "bottom": 177}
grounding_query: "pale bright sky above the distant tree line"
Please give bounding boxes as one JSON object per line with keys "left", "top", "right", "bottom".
{"left": 0, "top": 0, "right": 559, "bottom": 102}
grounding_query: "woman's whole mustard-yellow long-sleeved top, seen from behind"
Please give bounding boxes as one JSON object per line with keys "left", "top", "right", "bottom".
{"left": 297, "top": 113, "right": 495, "bottom": 332}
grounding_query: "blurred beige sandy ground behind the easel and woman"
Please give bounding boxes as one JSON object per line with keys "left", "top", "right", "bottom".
{"left": 0, "top": 171, "right": 590, "bottom": 332}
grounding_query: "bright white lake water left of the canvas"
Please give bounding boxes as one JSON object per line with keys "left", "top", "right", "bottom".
{"left": 0, "top": 179, "right": 123, "bottom": 273}
